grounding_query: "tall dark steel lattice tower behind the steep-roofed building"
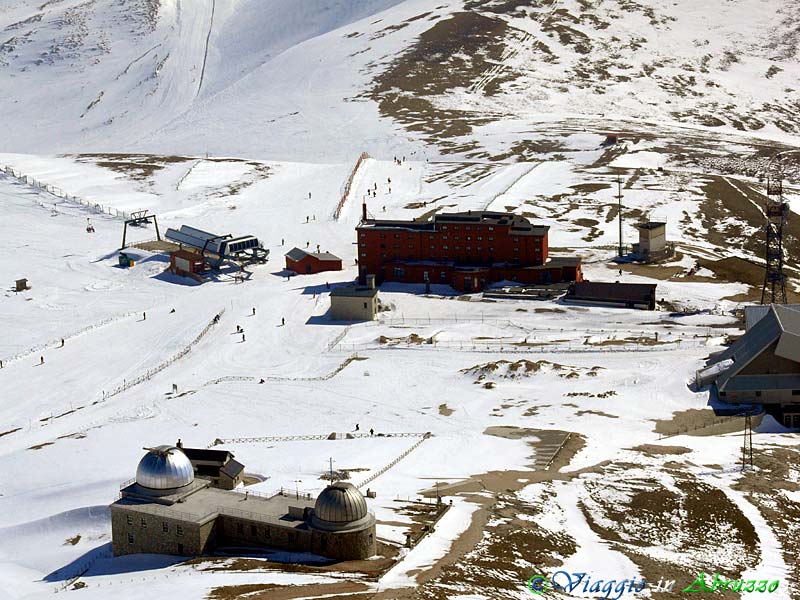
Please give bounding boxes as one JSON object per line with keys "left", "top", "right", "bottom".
{"left": 761, "top": 172, "right": 789, "bottom": 304}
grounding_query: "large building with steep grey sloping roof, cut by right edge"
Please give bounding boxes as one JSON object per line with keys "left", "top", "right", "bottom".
{"left": 697, "top": 304, "right": 800, "bottom": 428}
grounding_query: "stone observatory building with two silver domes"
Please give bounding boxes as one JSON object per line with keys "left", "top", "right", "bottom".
{"left": 111, "top": 446, "right": 376, "bottom": 560}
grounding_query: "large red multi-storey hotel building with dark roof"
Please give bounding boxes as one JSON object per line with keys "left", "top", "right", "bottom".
{"left": 356, "top": 206, "right": 583, "bottom": 292}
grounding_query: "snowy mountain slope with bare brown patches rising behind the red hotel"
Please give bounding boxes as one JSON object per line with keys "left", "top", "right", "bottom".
{"left": 0, "top": 0, "right": 800, "bottom": 160}
